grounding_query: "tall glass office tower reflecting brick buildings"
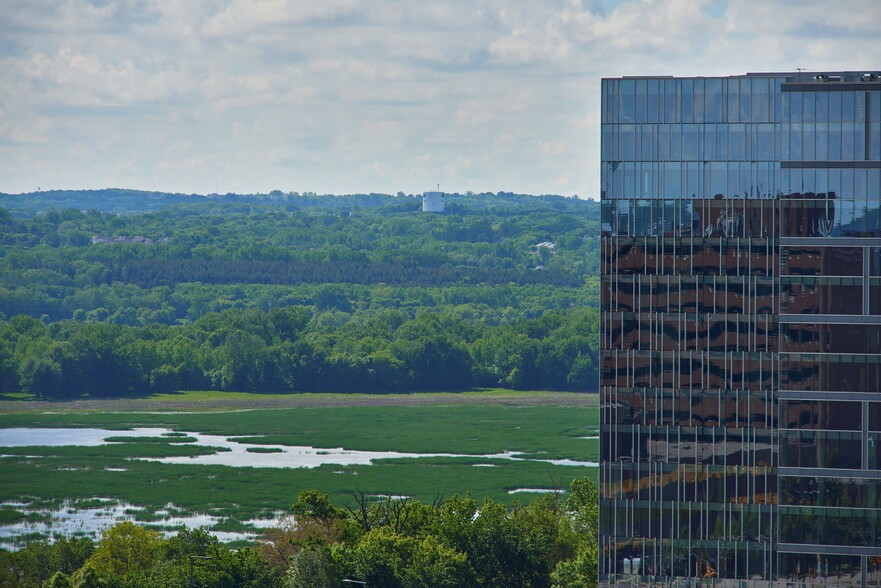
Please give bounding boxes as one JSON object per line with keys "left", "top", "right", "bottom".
{"left": 600, "top": 71, "right": 881, "bottom": 588}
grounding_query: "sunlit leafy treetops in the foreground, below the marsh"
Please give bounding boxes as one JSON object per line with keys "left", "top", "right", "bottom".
{"left": 0, "top": 479, "right": 598, "bottom": 588}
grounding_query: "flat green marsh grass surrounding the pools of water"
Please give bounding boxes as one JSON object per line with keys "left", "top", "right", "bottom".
{"left": 0, "top": 391, "right": 598, "bottom": 544}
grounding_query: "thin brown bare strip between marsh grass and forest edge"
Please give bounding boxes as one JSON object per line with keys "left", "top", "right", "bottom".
{"left": 0, "top": 392, "right": 599, "bottom": 414}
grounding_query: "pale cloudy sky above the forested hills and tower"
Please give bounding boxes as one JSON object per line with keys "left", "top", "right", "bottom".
{"left": 0, "top": 0, "right": 881, "bottom": 198}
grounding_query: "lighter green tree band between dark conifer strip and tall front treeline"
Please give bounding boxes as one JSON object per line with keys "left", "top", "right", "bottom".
{"left": 0, "top": 278, "right": 599, "bottom": 326}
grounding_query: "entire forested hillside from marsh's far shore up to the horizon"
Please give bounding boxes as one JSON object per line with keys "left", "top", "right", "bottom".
{"left": 0, "top": 190, "right": 599, "bottom": 398}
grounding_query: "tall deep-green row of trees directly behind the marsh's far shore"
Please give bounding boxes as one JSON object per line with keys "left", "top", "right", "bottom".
{"left": 0, "top": 306, "right": 598, "bottom": 398}
